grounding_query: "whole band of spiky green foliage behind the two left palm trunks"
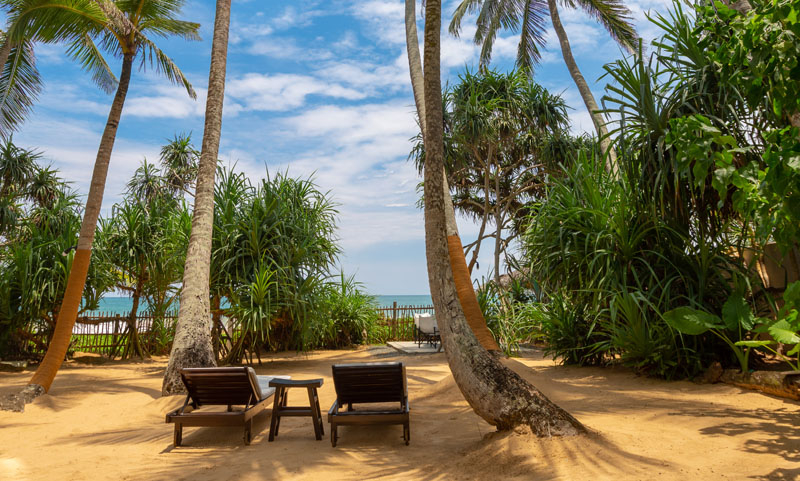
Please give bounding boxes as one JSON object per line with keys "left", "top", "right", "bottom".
{"left": 0, "top": 135, "right": 378, "bottom": 362}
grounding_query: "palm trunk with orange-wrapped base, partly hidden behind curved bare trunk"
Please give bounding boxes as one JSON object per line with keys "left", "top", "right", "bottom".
{"left": 405, "top": 0, "right": 500, "bottom": 351}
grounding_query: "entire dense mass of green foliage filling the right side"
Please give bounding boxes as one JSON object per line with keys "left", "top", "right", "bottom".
{"left": 525, "top": 0, "right": 800, "bottom": 376}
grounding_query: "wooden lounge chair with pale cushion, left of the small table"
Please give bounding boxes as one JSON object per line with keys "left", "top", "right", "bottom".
{"left": 167, "top": 367, "right": 289, "bottom": 446}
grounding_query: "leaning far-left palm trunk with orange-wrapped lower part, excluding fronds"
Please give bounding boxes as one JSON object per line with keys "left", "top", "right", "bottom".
{"left": 26, "top": 54, "right": 133, "bottom": 397}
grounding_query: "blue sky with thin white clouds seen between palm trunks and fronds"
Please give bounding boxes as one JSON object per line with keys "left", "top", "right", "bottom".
{"left": 14, "top": 0, "right": 669, "bottom": 294}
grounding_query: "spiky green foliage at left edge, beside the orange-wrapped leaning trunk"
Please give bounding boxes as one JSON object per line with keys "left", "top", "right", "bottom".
{"left": 0, "top": 140, "right": 113, "bottom": 356}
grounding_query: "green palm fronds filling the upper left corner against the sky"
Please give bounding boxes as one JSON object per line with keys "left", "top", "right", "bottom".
{"left": 0, "top": 0, "right": 199, "bottom": 136}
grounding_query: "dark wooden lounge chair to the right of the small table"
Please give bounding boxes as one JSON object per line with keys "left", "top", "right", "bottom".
{"left": 328, "top": 362, "right": 411, "bottom": 447}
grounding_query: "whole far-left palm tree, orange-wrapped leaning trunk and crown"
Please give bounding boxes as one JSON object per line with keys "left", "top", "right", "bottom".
{"left": 21, "top": 0, "right": 200, "bottom": 396}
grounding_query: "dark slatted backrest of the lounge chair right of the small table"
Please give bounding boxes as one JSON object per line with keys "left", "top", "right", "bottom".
{"left": 333, "top": 362, "right": 408, "bottom": 405}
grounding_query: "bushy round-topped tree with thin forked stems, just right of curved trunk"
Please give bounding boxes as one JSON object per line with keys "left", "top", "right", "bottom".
{"left": 411, "top": 70, "right": 568, "bottom": 282}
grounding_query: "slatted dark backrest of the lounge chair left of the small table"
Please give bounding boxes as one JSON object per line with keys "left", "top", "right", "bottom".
{"left": 181, "top": 367, "right": 261, "bottom": 406}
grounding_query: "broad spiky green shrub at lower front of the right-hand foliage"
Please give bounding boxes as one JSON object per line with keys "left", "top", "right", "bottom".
{"left": 525, "top": 152, "right": 749, "bottom": 377}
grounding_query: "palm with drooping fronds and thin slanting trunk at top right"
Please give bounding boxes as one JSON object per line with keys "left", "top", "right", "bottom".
{"left": 449, "top": 0, "right": 637, "bottom": 171}
